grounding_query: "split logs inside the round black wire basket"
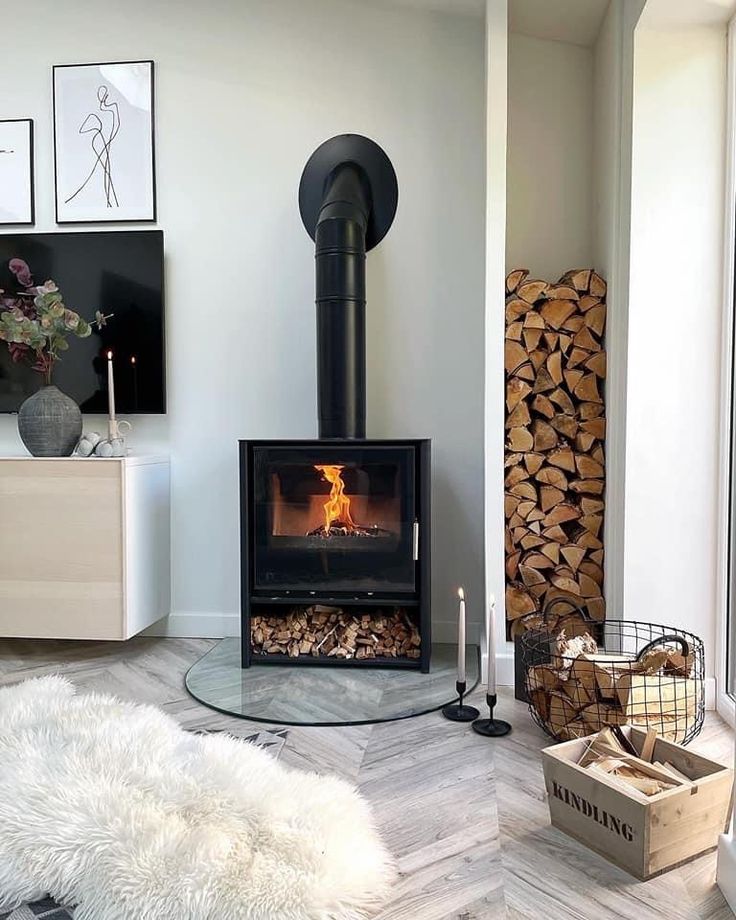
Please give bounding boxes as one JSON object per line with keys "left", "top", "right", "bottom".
{"left": 526, "top": 630, "right": 700, "bottom": 743}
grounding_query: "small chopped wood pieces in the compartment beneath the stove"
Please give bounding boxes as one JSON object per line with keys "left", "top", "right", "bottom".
{"left": 250, "top": 604, "right": 422, "bottom": 660}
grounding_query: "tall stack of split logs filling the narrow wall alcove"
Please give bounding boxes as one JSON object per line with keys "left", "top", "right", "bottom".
{"left": 505, "top": 269, "right": 606, "bottom": 636}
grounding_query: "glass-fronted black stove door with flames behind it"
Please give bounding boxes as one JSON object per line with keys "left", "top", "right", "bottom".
{"left": 253, "top": 445, "right": 416, "bottom": 593}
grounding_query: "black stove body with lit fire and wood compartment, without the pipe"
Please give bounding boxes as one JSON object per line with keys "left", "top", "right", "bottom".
{"left": 240, "top": 440, "right": 431, "bottom": 671}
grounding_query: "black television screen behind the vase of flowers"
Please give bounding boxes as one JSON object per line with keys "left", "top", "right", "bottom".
{"left": 0, "top": 230, "right": 166, "bottom": 415}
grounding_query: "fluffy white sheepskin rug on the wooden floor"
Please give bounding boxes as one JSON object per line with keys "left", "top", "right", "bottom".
{"left": 0, "top": 677, "right": 393, "bottom": 920}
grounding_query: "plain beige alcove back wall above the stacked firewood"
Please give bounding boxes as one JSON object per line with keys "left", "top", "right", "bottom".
{"left": 506, "top": 34, "right": 594, "bottom": 280}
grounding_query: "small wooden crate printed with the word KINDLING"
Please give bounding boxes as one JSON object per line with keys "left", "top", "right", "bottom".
{"left": 542, "top": 725, "right": 733, "bottom": 879}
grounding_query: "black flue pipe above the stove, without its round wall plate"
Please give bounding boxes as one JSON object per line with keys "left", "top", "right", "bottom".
{"left": 314, "top": 163, "right": 371, "bottom": 439}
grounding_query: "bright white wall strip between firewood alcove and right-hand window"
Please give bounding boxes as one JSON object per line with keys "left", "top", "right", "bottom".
{"left": 624, "top": 23, "right": 726, "bottom": 675}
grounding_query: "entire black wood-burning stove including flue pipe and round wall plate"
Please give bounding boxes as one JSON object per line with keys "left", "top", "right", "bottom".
{"left": 240, "top": 135, "right": 431, "bottom": 671}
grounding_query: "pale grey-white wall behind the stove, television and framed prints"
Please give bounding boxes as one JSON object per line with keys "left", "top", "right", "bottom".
{"left": 0, "top": 0, "right": 484, "bottom": 634}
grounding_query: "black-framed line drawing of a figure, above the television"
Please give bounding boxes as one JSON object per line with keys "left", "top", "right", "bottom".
{"left": 53, "top": 61, "right": 156, "bottom": 224}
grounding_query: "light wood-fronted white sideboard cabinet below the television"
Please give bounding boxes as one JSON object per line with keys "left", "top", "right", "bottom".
{"left": 0, "top": 457, "right": 170, "bottom": 640}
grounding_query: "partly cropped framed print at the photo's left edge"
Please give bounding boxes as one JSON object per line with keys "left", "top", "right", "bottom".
{"left": 0, "top": 118, "right": 35, "bottom": 227}
